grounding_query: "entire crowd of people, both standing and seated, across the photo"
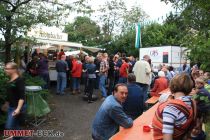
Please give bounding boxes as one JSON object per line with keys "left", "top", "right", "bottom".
{"left": 3, "top": 48, "right": 210, "bottom": 140}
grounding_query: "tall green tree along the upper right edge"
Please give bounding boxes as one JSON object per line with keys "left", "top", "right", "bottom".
{"left": 161, "top": 0, "right": 210, "bottom": 71}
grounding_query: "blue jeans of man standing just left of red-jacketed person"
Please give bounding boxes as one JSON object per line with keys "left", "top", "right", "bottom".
{"left": 57, "top": 72, "right": 67, "bottom": 94}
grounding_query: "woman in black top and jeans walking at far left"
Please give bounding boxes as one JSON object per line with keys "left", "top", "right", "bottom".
{"left": 2, "top": 62, "right": 25, "bottom": 130}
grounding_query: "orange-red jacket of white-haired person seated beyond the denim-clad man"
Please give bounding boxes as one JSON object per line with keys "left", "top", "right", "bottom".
{"left": 150, "top": 77, "right": 168, "bottom": 96}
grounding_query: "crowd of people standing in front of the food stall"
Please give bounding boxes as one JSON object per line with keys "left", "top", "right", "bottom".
{"left": 22, "top": 50, "right": 139, "bottom": 103}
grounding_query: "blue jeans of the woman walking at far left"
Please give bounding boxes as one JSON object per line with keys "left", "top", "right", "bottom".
{"left": 5, "top": 104, "right": 26, "bottom": 130}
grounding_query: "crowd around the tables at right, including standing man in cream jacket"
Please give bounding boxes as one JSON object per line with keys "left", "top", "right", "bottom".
{"left": 92, "top": 55, "right": 210, "bottom": 140}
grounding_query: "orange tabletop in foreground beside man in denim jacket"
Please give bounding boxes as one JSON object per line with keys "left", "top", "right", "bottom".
{"left": 111, "top": 103, "right": 159, "bottom": 140}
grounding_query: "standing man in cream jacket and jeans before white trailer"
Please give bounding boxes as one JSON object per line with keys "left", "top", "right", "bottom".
{"left": 133, "top": 55, "right": 151, "bottom": 102}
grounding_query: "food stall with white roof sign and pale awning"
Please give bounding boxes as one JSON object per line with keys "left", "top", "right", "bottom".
{"left": 28, "top": 26, "right": 101, "bottom": 81}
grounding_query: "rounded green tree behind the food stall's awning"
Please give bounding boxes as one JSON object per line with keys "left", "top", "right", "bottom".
{"left": 64, "top": 17, "right": 103, "bottom": 46}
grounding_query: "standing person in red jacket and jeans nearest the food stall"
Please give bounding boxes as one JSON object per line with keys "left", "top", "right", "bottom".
{"left": 71, "top": 55, "right": 82, "bottom": 94}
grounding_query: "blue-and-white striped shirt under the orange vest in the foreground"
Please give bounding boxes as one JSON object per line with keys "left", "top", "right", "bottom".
{"left": 162, "top": 96, "right": 192, "bottom": 134}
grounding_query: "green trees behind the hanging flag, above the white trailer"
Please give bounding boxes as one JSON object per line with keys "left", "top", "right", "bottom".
{"left": 108, "top": 23, "right": 181, "bottom": 56}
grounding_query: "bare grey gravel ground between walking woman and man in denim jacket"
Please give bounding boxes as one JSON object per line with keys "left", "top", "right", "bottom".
{"left": 32, "top": 87, "right": 102, "bottom": 140}
